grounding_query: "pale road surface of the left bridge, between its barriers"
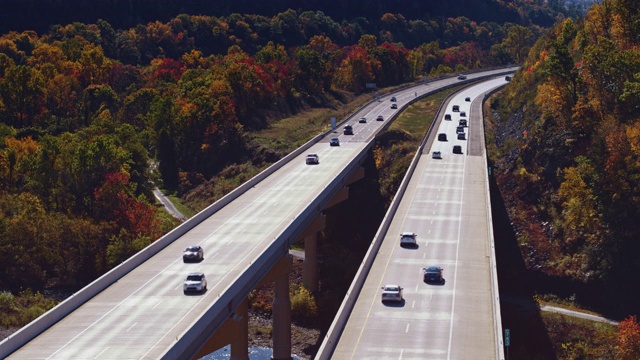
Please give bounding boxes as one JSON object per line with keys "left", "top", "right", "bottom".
{"left": 0, "top": 70, "right": 516, "bottom": 359}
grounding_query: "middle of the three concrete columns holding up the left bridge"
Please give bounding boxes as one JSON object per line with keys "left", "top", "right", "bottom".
{"left": 271, "top": 260, "right": 293, "bottom": 360}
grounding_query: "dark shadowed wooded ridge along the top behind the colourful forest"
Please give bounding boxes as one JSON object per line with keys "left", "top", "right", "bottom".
{"left": 0, "top": 0, "right": 580, "bottom": 33}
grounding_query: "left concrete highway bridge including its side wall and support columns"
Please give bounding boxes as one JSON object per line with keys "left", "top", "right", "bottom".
{"left": 0, "top": 68, "right": 515, "bottom": 359}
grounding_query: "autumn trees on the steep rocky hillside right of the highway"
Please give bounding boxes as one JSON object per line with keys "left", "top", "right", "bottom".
{"left": 494, "top": 0, "right": 640, "bottom": 320}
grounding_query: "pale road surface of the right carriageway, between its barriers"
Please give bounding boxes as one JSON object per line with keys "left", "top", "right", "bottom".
{"left": 332, "top": 77, "right": 505, "bottom": 359}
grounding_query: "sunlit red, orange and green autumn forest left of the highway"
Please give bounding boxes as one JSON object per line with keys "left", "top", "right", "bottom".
{"left": 0, "top": 4, "right": 542, "bottom": 300}
